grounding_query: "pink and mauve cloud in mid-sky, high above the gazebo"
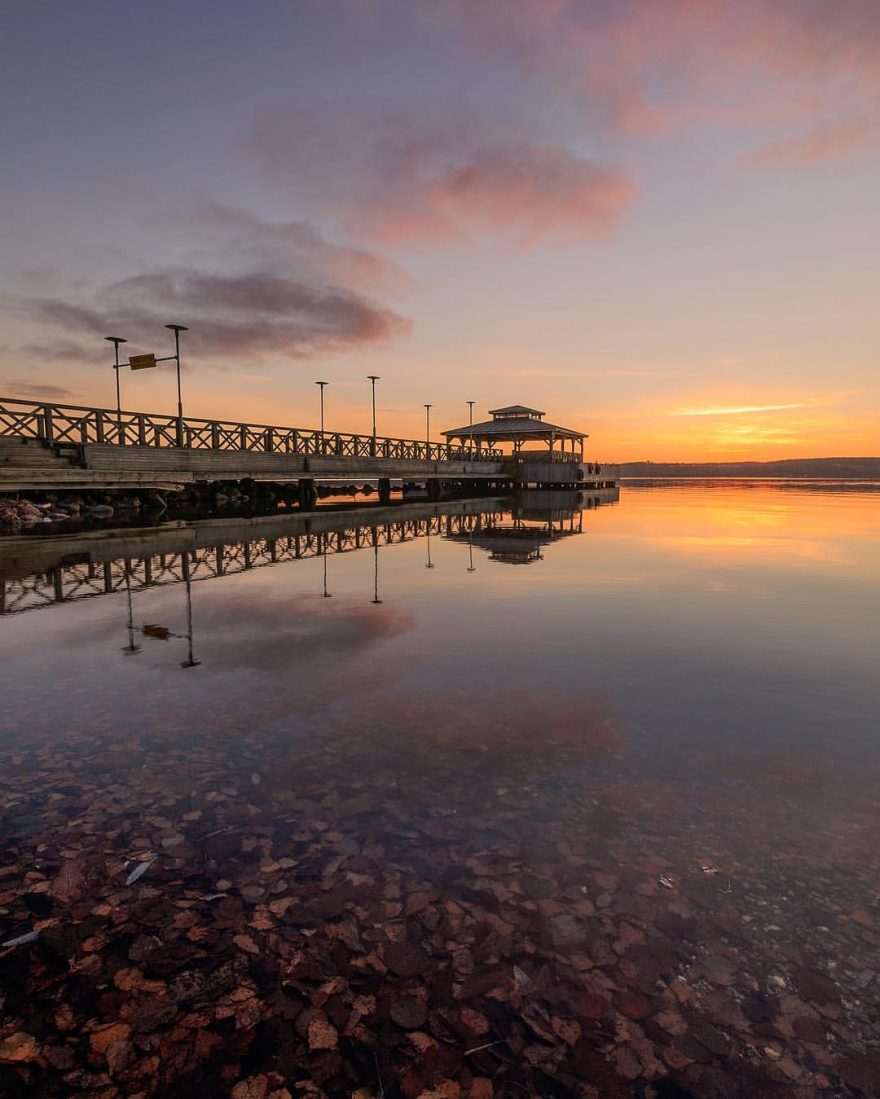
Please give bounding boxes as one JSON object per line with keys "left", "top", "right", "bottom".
{"left": 245, "top": 108, "right": 634, "bottom": 245}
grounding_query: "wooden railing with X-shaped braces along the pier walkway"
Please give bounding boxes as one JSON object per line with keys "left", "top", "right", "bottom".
{"left": 0, "top": 397, "right": 502, "bottom": 462}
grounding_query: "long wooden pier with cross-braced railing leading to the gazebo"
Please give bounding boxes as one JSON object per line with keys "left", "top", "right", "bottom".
{"left": 0, "top": 398, "right": 616, "bottom": 502}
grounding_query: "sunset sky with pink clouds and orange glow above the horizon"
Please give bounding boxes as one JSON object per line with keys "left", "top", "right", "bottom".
{"left": 0, "top": 0, "right": 880, "bottom": 462}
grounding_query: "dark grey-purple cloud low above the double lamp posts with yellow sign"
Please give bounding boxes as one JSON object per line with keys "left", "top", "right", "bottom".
{"left": 16, "top": 207, "right": 410, "bottom": 362}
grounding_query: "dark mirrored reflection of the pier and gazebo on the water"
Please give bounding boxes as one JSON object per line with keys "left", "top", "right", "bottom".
{"left": 0, "top": 490, "right": 616, "bottom": 619}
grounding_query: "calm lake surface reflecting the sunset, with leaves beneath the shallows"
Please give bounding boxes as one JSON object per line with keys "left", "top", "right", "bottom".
{"left": 0, "top": 482, "right": 880, "bottom": 1099}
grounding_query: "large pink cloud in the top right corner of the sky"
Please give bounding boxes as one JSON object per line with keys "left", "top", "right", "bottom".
{"left": 430, "top": 0, "right": 880, "bottom": 165}
